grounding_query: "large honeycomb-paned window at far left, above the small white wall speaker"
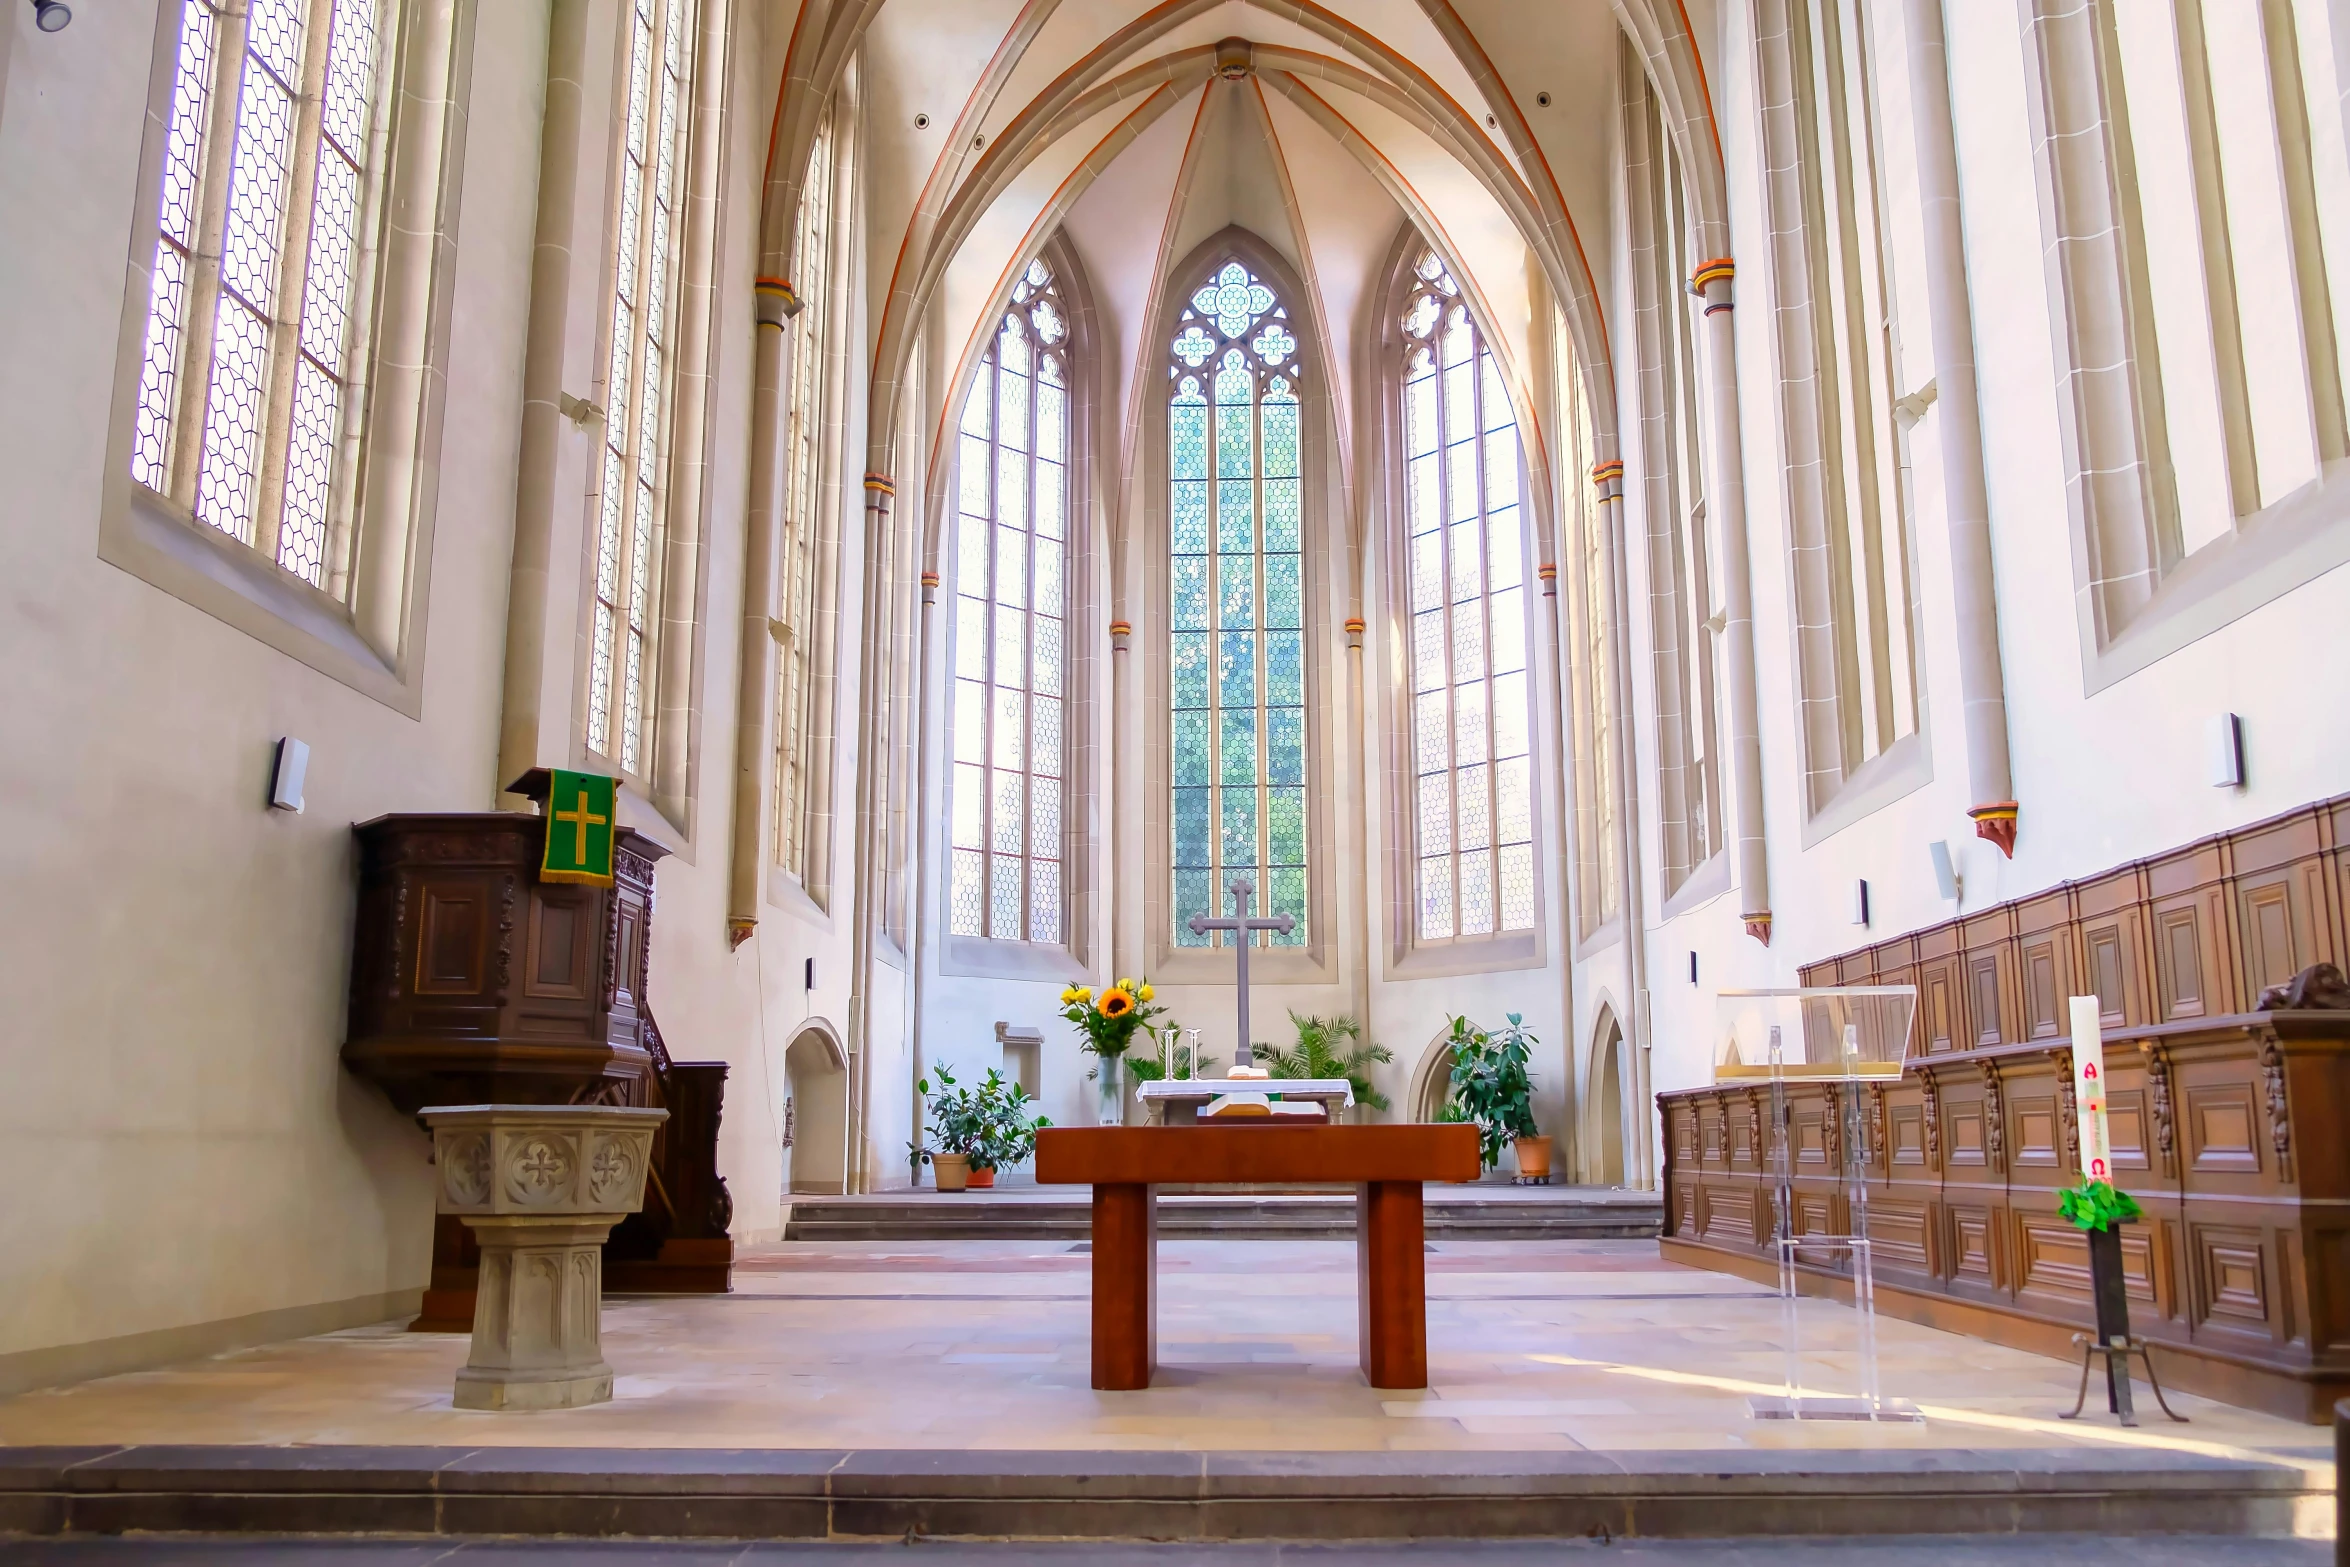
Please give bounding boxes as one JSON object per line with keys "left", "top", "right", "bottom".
{"left": 132, "top": 0, "right": 397, "bottom": 597}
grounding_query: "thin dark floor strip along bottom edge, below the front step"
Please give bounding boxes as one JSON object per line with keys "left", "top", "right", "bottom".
{"left": 0, "top": 1534, "right": 2334, "bottom": 1567}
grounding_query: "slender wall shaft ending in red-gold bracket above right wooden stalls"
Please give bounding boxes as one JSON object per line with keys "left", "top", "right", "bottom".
{"left": 1904, "top": 0, "right": 2016, "bottom": 855}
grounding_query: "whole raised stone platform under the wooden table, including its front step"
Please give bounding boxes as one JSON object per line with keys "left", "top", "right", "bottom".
{"left": 0, "top": 1240, "right": 2334, "bottom": 1539}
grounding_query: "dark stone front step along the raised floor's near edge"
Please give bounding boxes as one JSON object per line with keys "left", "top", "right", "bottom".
{"left": 0, "top": 1437, "right": 2334, "bottom": 1562}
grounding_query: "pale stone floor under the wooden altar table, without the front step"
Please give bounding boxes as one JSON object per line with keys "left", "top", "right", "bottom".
{"left": 0, "top": 1240, "right": 2331, "bottom": 1482}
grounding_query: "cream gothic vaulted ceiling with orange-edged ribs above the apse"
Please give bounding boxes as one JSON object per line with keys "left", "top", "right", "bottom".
{"left": 761, "top": 0, "right": 1718, "bottom": 535}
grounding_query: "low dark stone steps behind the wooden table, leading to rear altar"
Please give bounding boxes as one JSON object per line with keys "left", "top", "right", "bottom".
{"left": 783, "top": 1186, "right": 1664, "bottom": 1240}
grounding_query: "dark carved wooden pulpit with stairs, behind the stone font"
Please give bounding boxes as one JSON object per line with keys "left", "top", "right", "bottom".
{"left": 343, "top": 771, "right": 733, "bottom": 1332}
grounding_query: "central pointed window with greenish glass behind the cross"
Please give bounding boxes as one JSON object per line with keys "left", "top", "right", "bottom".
{"left": 1168, "top": 261, "right": 1307, "bottom": 947}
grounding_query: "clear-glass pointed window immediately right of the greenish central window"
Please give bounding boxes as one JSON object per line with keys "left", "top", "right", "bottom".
{"left": 1401, "top": 251, "right": 1535, "bottom": 942}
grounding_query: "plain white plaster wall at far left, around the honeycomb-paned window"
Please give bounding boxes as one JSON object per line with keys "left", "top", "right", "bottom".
{"left": 0, "top": 0, "right": 545, "bottom": 1356}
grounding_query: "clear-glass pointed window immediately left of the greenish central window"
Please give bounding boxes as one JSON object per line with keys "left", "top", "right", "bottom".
{"left": 947, "top": 261, "right": 1069, "bottom": 942}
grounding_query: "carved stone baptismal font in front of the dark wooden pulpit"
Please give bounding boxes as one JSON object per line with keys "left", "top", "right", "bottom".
{"left": 423, "top": 1104, "right": 670, "bottom": 1410}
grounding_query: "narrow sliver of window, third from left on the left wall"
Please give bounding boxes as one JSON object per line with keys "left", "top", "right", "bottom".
{"left": 776, "top": 120, "right": 834, "bottom": 876}
